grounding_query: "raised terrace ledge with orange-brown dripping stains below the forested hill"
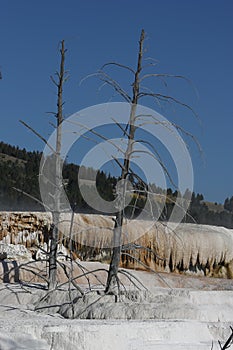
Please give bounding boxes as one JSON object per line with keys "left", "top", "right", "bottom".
{"left": 0, "top": 212, "right": 233, "bottom": 278}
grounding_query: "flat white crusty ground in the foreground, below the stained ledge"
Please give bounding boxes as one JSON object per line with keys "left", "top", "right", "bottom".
{"left": 0, "top": 263, "right": 233, "bottom": 350}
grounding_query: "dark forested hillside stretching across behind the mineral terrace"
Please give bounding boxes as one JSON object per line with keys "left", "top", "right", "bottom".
{"left": 0, "top": 142, "right": 233, "bottom": 228}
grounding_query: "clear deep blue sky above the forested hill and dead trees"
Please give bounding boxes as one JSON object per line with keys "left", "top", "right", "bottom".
{"left": 0, "top": 0, "right": 233, "bottom": 202}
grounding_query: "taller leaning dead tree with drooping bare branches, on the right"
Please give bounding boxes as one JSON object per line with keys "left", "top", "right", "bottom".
{"left": 93, "top": 29, "right": 198, "bottom": 293}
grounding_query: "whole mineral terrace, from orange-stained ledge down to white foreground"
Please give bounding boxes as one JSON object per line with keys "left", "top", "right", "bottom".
{"left": 0, "top": 212, "right": 233, "bottom": 350}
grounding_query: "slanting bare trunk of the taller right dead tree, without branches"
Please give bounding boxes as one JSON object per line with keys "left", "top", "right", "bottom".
{"left": 105, "top": 30, "right": 145, "bottom": 293}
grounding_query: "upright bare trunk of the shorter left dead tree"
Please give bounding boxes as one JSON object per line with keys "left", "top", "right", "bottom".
{"left": 49, "top": 40, "right": 66, "bottom": 289}
